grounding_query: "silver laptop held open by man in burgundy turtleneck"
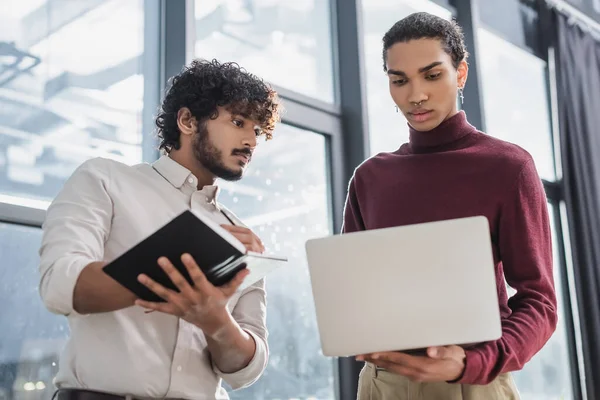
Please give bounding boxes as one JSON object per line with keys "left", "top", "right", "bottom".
{"left": 306, "top": 217, "right": 502, "bottom": 357}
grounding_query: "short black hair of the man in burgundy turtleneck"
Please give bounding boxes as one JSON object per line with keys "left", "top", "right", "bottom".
{"left": 383, "top": 12, "right": 468, "bottom": 72}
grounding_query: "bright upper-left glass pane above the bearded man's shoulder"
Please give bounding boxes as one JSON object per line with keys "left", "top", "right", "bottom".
{"left": 0, "top": 0, "right": 151, "bottom": 203}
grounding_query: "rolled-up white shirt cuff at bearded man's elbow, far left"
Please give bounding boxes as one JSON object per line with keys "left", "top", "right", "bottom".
{"left": 40, "top": 257, "right": 92, "bottom": 316}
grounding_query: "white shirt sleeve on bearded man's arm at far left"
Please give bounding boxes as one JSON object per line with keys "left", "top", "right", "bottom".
{"left": 39, "top": 159, "right": 113, "bottom": 315}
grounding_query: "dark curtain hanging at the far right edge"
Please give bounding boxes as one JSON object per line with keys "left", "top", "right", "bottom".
{"left": 553, "top": 11, "right": 600, "bottom": 399}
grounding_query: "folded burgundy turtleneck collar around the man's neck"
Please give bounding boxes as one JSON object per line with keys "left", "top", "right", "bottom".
{"left": 409, "top": 111, "right": 476, "bottom": 152}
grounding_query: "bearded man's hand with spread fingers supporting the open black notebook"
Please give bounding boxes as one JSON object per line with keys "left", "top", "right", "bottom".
{"left": 135, "top": 254, "right": 249, "bottom": 337}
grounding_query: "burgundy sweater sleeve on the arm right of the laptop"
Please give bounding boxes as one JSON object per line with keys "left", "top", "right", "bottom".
{"left": 459, "top": 160, "right": 557, "bottom": 384}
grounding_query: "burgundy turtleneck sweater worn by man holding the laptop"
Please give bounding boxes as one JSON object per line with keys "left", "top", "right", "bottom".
{"left": 342, "top": 111, "right": 557, "bottom": 384}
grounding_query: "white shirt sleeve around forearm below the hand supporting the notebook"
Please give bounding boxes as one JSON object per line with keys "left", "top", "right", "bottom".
{"left": 213, "top": 279, "right": 269, "bottom": 390}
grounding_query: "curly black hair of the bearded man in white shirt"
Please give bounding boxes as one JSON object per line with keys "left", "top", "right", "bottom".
{"left": 156, "top": 60, "right": 281, "bottom": 152}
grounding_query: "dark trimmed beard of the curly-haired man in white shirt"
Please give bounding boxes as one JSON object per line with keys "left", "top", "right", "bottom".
{"left": 192, "top": 124, "right": 251, "bottom": 181}
